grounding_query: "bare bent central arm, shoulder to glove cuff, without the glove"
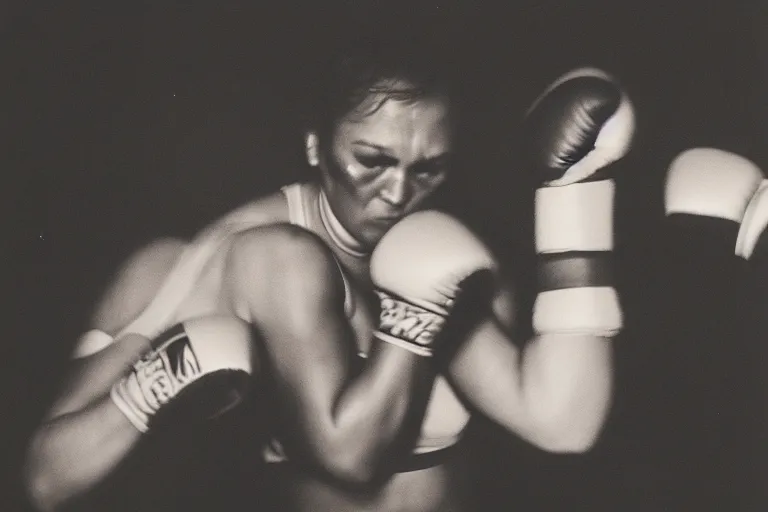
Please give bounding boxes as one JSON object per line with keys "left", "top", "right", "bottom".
{"left": 228, "top": 225, "right": 444, "bottom": 484}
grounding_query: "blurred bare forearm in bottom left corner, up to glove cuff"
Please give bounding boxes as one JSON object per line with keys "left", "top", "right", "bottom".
{"left": 24, "top": 395, "right": 141, "bottom": 510}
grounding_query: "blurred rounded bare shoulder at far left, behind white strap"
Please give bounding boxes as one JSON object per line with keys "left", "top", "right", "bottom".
{"left": 92, "top": 238, "right": 186, "bottom": 335}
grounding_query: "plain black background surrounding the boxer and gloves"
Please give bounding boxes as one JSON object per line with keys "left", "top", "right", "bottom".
{"left": 2, "top": 0, "right": 768, "bottom": 510}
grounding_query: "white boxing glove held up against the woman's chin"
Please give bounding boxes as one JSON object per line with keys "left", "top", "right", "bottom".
{"left": 371, "top": 211, "right": 495, "bottom": 356}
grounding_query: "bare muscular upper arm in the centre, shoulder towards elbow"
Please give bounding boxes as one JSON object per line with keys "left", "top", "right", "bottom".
{"left": 229, "top": 225, "right": 356, "bottom": 452}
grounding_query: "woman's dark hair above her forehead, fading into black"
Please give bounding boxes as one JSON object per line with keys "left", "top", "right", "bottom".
{"left": 304, "top": 32, "right": 453, "bottom": 137}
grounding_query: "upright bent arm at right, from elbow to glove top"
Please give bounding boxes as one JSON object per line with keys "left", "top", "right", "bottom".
{"left": 428, "top": 69, "right": 634, "bottom": 451}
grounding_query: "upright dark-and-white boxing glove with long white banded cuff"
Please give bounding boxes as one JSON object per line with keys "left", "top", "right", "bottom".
{"left": 525, "top": 68, "right": 635, "bottom": 336}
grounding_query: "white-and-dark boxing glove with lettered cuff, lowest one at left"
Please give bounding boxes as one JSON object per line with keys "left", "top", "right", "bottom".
{"left": 110, "top": 317, "right": 254, "bottom": 432}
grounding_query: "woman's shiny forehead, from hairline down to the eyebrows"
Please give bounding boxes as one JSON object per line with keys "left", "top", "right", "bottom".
{"left": 337, "top": 94, "right": 451, "bottom": 147}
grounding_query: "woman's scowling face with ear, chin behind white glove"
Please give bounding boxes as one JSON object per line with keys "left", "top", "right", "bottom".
{"left": 308, "top": 87, "right": 452, "bottom": 248}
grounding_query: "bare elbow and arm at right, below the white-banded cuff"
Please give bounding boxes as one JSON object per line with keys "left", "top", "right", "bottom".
{"left": 446, "top": 280, "right": 613, "bottom": 452}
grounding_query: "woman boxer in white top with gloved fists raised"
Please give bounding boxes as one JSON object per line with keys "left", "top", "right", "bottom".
{"left": 26, "top": 34, "right": 625, "bottom": 511}
